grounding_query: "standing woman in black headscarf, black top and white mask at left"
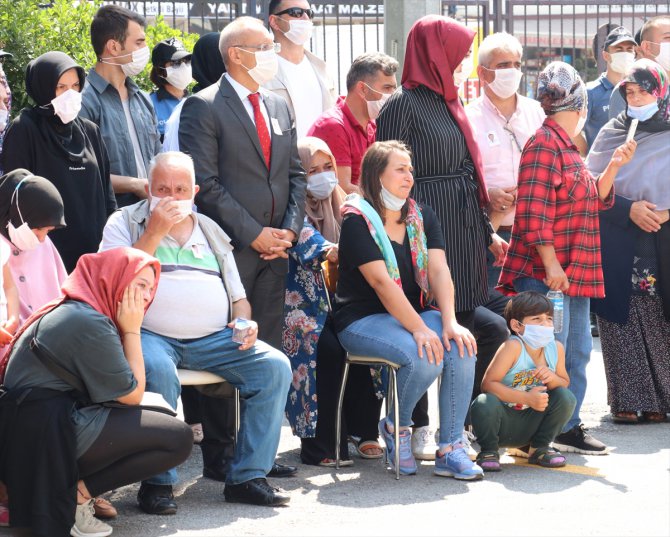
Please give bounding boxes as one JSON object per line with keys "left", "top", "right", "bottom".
{"left": 2, "top": 51, "right": 116, "bottom": 272}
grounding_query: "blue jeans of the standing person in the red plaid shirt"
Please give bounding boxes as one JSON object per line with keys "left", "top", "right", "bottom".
{"left": 514, "top": 278, "right": 593, "bottom": 432}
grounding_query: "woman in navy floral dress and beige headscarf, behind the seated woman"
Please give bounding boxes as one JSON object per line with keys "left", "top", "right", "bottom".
{"left": 282, "top": 137, "right": 383, "bottom": 466}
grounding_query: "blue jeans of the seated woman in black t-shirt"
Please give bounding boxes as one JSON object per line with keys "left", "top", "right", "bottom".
{"left": 338, "top": 310, "right": 476, "bottom": 444}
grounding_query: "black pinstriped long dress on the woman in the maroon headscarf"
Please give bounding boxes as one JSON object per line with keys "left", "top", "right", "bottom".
{"left": 377, "top": 86, "right": 493, "bottom": 312}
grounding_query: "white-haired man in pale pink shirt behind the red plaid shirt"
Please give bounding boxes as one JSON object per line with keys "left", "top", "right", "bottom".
{"left": 465, "top": 32, "right": 545, "bottom": 304}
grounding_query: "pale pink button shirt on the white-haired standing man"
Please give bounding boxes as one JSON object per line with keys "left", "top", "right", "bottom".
{"left": 465, "top": 92, "right": 545, "bottom": 226}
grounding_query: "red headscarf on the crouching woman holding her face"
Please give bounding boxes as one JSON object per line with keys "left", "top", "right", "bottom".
{"left": 0, "top": 247, "right": 161, "bottom": 380}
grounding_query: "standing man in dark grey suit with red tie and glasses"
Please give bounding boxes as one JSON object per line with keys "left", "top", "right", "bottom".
{"left": 179, "top": 17, "right": 306, "bottom": 348}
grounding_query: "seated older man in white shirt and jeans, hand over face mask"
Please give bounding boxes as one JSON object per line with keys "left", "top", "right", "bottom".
{"left": 100, "top": 152, "right": 292, "bottom": 514}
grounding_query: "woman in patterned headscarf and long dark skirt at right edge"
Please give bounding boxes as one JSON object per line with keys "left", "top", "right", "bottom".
{"left": 586, "top": 59, "right": 670, "bottom": 423}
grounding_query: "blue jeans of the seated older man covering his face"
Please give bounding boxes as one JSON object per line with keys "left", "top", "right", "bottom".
{"left": 142, "top": 328, "right": 292, "bottom": 485}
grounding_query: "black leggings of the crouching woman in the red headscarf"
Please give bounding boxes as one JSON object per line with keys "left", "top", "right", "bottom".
{"left": 77, "top": 408, "right": 193, "bottom": 496}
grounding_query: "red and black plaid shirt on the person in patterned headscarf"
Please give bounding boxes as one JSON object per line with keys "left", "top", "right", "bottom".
{"left": 498, "top": 118, "right": 614, "bottom": 298}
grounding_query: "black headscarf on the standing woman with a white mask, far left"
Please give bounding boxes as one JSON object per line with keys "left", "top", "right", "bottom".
{"left": 25, "top": 51, "right": 86, "bottom": 162}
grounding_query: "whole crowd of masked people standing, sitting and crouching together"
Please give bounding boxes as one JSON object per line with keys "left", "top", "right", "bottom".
{"left": 0, "top": 0, "right": 670, "bottom": 537}
